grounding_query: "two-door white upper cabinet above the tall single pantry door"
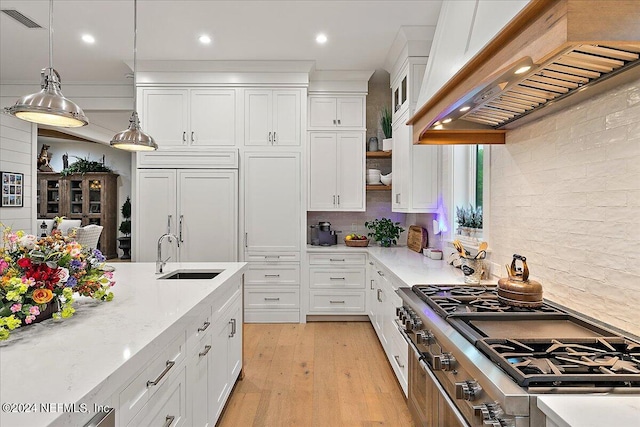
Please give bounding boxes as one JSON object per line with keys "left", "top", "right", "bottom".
{"left": 244, "top": 89, "right": 302, "bottom": 146}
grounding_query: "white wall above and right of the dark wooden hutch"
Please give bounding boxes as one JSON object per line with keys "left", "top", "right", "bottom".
{"left": 38, "top": 137, "right": 132, "bottom": 225}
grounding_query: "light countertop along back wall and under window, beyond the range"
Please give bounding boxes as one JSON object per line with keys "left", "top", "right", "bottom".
{"left": 306, "top": 244, "right": 496, "bottom": 286}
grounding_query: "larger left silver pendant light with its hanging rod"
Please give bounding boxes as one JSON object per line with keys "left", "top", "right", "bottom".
{"left": 5, "top": 0, "right": 89, "bottom": 127}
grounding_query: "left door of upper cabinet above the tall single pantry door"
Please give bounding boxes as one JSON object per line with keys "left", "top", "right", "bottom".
{"left": 244, "top": 90, "right": 273, "bottom": 145}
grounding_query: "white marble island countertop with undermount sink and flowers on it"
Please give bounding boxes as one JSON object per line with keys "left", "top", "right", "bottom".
{"left": 0, "top": 263, "right": 246, "bottom": 427}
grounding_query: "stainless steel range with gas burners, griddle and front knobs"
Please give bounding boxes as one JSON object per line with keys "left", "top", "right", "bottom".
{"left": 396, "top": 285, "right": 640, "bottom": 427}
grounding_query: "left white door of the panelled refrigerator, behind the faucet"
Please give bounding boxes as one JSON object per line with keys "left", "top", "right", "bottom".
{"left": 133, "top": 169, "right": 177, "bottom": 262}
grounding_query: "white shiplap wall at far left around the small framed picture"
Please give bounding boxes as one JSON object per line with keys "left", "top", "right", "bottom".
{"left": 0, "top": 114, "right": 37, "bottom": 232}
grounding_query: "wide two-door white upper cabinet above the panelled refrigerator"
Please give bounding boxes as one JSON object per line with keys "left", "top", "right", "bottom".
{"left": 140, "top": 88, "right": 236, "bottom": 149}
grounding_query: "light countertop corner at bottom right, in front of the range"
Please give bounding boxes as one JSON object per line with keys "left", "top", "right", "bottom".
{"left": 538, "top": 395, "right": 640, "bottom": 427}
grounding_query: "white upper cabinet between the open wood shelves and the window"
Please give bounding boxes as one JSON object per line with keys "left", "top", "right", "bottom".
{"left": 391, "top": 110, "right": 441, "bottom": 213}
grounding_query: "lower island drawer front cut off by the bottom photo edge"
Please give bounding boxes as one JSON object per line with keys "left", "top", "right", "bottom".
{"left": 129, "top": 366, "right": 187, "bottom": 427}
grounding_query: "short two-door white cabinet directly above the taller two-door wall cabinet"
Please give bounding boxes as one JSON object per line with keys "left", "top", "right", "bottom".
{"left": 309, "top": 95, "right": 366, "bottom": 130}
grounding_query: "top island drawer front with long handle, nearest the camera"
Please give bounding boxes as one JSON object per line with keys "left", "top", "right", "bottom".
{"left": 118, "top": 330, "right": 185, "bottom": 425}
